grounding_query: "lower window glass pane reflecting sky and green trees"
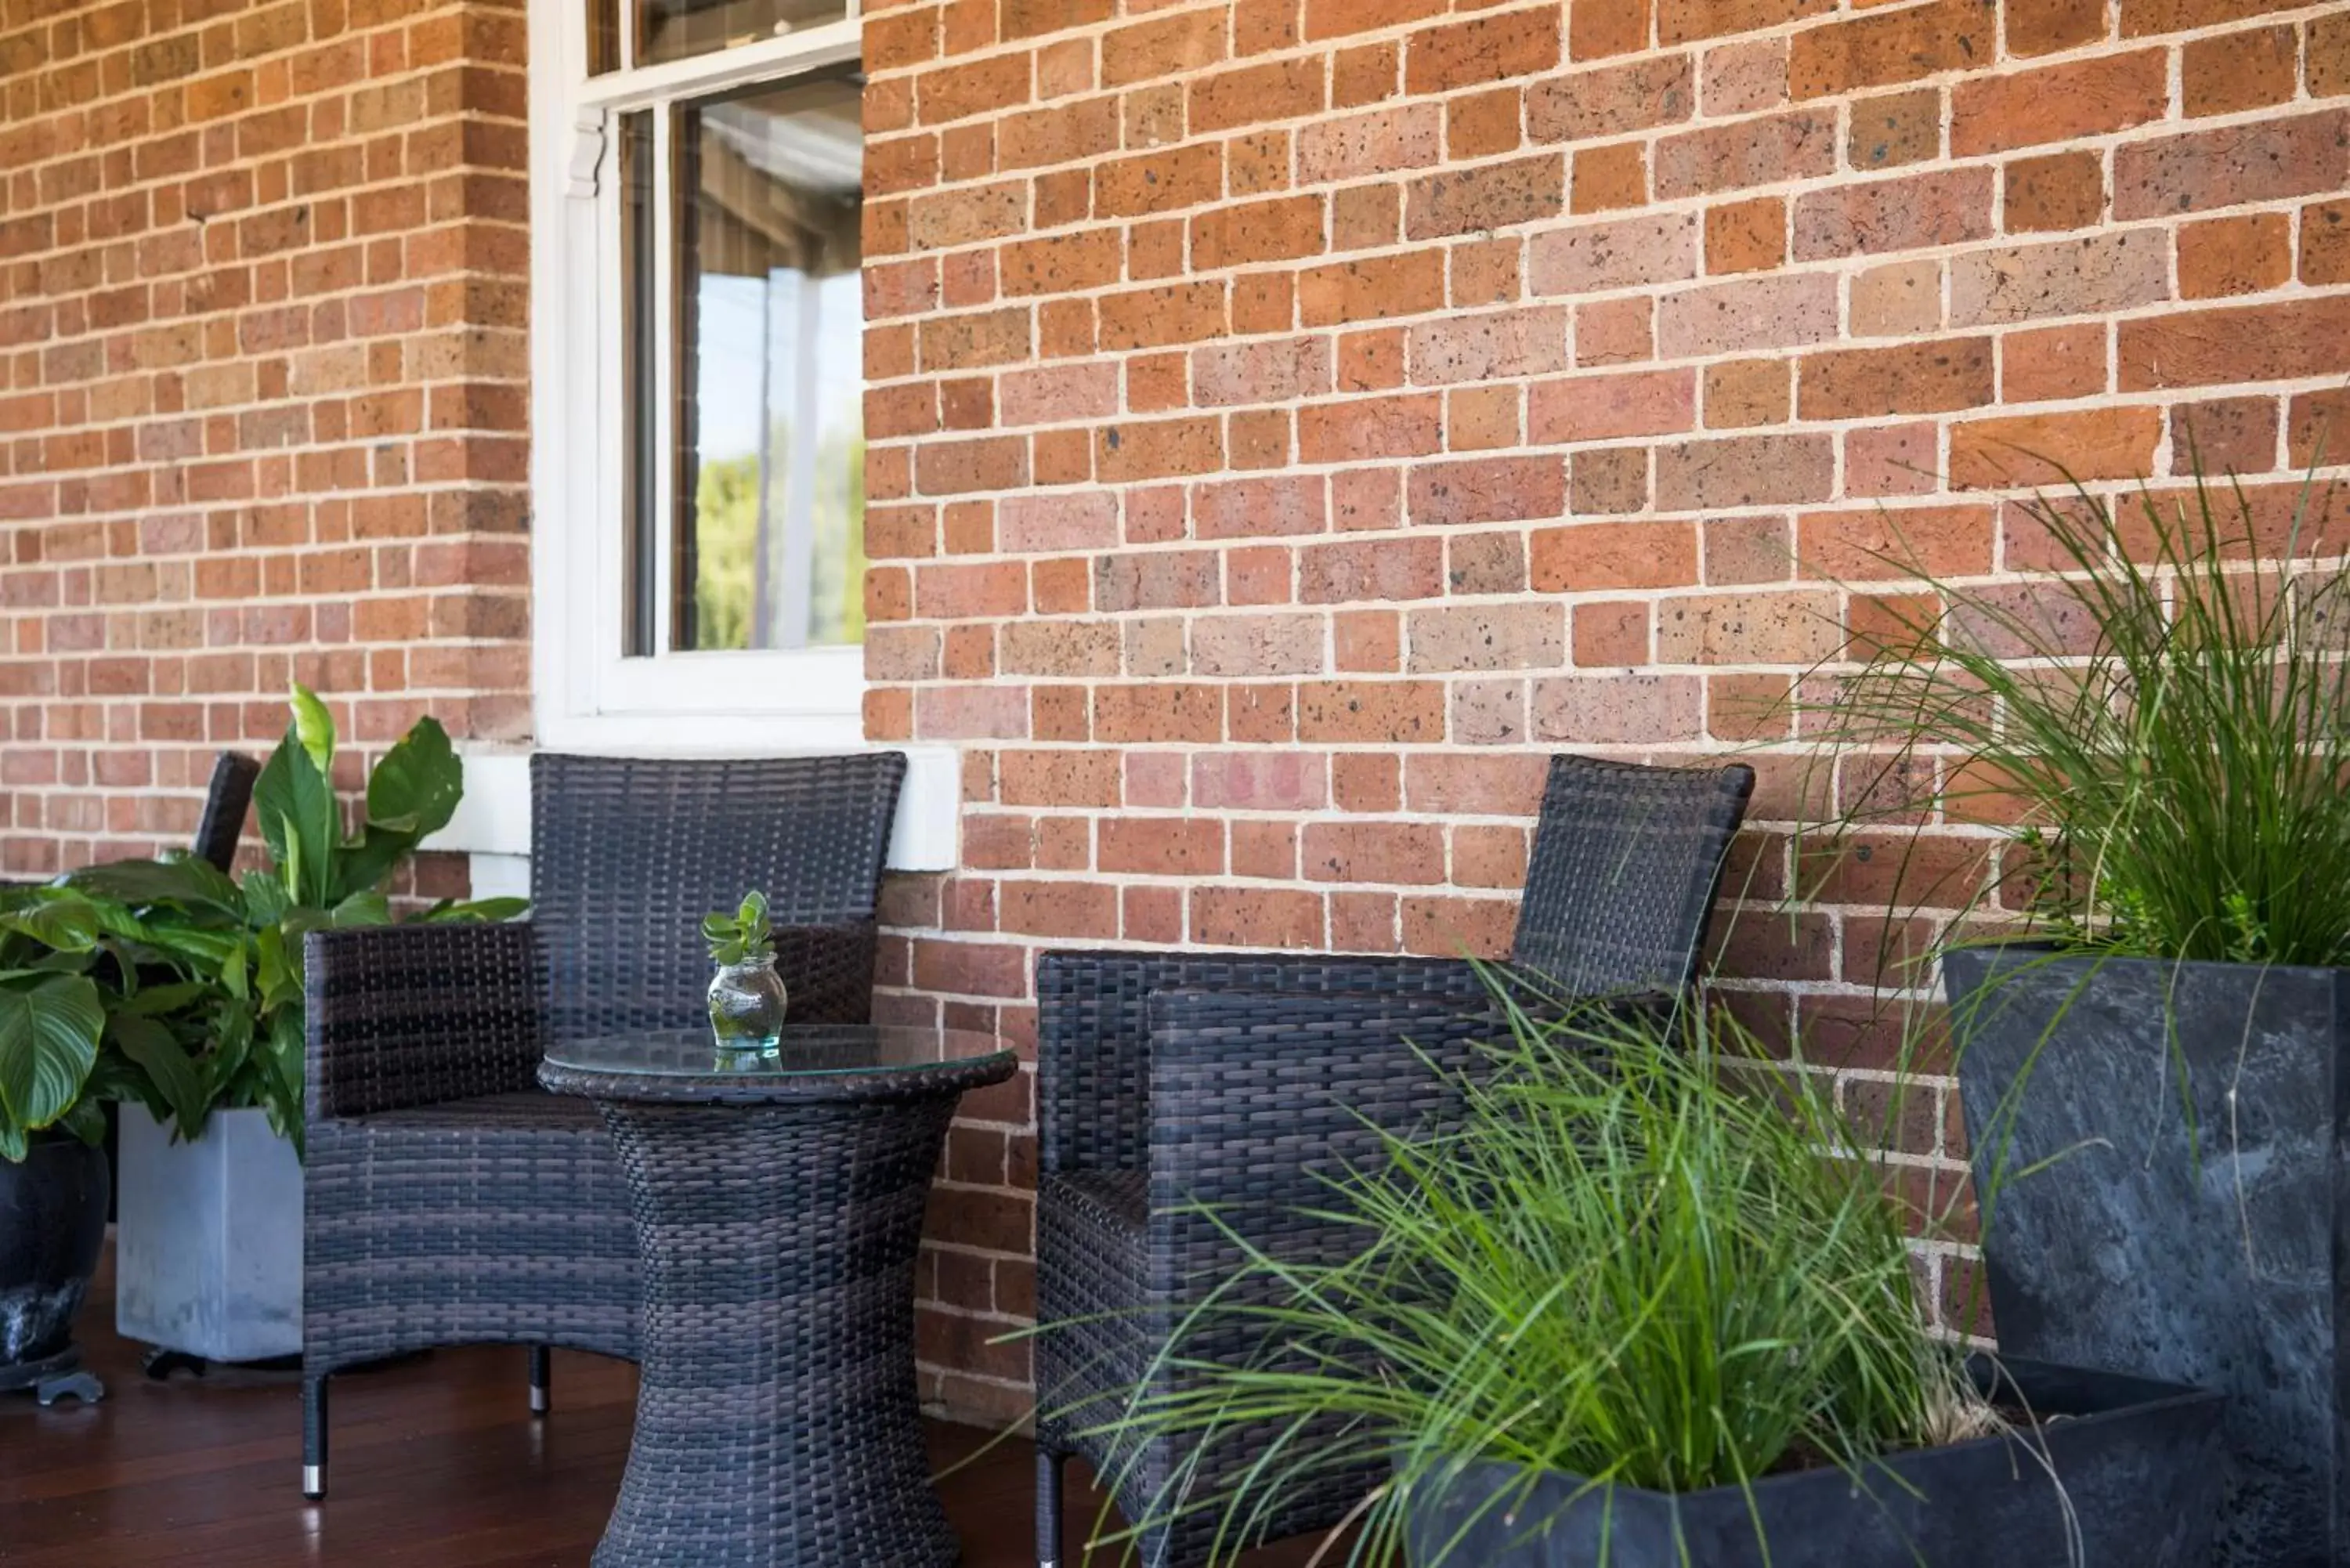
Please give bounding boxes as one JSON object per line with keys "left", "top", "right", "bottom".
{"left": 670, "top": 80, "right": 865, "bottom": 649}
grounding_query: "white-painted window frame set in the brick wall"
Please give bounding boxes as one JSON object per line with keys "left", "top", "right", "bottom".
{"left": 529, "top": 0, "right": 865, "bottom": 752}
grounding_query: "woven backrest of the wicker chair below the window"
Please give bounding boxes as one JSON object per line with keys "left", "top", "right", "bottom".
{"left": 531, "top": 752, "right": 905, "bottom": 1039}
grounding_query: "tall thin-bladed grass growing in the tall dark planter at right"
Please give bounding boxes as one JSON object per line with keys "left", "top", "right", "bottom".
{"left": 1805, "top": 472, "right": 2350, "bottom": 966}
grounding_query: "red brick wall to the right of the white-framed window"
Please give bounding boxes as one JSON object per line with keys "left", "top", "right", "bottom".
{"left": 867, "top": 0, "right": 2350, "bottom": 1411}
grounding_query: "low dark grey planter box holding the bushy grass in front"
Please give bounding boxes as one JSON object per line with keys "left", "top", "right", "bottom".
{"left": 1410, "top": 1361, "right": 2221, "bottom": 1568}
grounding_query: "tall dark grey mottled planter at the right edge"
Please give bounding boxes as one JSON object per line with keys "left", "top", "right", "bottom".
{"left": 1943, "top": 948, "right": 2350, "bottom": 1568}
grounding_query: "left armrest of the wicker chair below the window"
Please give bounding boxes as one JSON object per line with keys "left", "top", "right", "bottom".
{"left": 303, "top": 924, "right": 545, "bottom": 1126}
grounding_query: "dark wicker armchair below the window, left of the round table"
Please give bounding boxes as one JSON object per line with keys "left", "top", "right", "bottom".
{"left": 303, "top": 752, "right": 905, "bottom": 1498}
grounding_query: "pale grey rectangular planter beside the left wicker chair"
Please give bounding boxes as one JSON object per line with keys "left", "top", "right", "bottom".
{"left": 115, "top": 1105, "right": 301, "bottom": 1361}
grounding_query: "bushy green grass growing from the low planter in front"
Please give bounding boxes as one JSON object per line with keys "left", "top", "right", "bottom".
{"left": 1072, "top": 1006, "right": 1993, "bottom": 1568}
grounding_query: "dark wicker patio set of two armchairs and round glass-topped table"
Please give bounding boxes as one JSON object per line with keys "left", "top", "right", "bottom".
{"left": 280, "top": 752, "right": 1753, "bottom": 1568}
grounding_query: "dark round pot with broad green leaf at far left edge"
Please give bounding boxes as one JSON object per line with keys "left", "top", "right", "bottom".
{"left": 0, "top": 889, "right": 108, "bottom": 1404}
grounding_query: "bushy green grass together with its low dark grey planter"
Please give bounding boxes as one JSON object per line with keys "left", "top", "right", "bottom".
{"left": 1074, "top": 1009, "right": 2218, "bottom": 1568}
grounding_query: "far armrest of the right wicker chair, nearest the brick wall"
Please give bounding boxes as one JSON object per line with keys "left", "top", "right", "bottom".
{"left": 1036, "top": 950, "right": 1485, "bottom": 1171}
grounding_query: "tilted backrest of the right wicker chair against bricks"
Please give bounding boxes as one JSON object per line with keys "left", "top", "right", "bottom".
{"left": 1511, "top": 757, "right": 1755, "bottom": 997}
